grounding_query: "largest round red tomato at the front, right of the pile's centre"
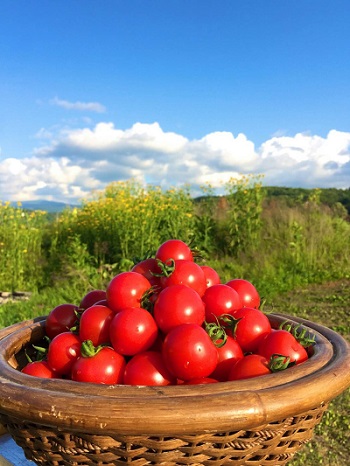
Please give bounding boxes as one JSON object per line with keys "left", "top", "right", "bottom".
{"left": 163, "top": 324, "right": 218, "bottom": 381}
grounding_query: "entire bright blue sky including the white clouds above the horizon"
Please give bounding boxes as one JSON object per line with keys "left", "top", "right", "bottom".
{"left": 0, "top": 0, "right": 350, "bottom": 202}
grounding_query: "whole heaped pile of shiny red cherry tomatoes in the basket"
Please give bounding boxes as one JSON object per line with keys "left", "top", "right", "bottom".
{"left": 22, "top": 239, "right": 312, "bottom": 385}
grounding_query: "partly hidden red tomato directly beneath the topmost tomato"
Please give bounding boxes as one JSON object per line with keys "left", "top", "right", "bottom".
{"left": 160, "top": 260, "right": 207, "bottom": 296}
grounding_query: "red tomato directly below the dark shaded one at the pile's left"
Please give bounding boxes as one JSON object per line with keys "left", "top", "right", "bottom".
{"left": 47, "top": 332, "right": 81, "bottom": 375}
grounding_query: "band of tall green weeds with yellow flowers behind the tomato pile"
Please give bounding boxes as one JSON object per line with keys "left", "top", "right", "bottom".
{"left": 0, "top": 176, "right": 350, "bottom": 296}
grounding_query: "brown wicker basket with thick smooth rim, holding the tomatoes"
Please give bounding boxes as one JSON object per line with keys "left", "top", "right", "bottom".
{"left": 0, "top": 315, "right": 350, "bottom": 466}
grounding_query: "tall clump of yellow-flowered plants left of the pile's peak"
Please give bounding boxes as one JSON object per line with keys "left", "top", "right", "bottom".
{"left": 50, "top": 180, "right": 193, "bottom": 269}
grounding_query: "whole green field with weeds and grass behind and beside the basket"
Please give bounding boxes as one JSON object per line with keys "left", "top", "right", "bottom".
{"left": 0, "top": 177, "right": 350, "bottom": 466}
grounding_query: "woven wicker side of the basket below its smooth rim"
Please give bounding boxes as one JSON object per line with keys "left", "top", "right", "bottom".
{"left": 2, "top": 405, "right": 327, "bottom": 466}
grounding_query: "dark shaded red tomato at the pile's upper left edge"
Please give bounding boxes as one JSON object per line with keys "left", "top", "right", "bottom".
{"left": 45, "top": 303, "right": 79, "bottom": 339}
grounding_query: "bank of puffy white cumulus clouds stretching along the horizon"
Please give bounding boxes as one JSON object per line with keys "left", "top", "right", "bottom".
{"left": 0, "top": 122, "right": 350, "bottom": 202}
